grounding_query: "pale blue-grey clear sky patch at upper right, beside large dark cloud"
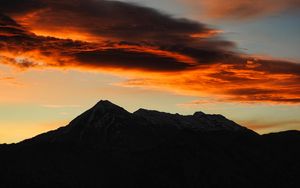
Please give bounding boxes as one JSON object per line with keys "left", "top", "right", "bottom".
{"left": 121, "top": 0, "right": 300, "bottom": 60}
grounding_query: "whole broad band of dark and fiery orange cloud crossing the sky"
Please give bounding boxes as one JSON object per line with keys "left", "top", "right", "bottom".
{"left": 0, "top": 0, "right": 300, "bottom": 104}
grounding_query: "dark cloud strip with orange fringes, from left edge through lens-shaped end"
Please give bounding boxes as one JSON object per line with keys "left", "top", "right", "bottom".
{"left": 0, "top": 12, "right": 198, "bottom": 71}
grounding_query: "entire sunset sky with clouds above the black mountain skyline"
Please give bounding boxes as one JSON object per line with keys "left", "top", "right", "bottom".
{"left": 0, "top": 0, "right": 300, "bottom": 143}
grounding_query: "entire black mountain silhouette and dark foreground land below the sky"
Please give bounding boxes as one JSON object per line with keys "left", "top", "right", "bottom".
{"left": 0, "top": 101, "right": 300, "bottom": 188}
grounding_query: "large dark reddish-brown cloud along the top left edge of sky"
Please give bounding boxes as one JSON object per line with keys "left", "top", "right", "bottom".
{"left": 0, "top": 0, "right": 211, "bottom": 43}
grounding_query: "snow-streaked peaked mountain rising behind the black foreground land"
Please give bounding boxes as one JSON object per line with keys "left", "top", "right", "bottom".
{"left": 22, "top": 101, "right": 256, "bottom": 150}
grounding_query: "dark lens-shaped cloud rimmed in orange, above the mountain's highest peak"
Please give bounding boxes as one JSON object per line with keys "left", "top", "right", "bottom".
{"left": 74, "top": 49, "right": 193, "bottom": 72}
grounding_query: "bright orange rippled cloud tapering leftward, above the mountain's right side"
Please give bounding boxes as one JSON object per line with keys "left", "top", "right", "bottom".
{"left": 119, "top": 63, "right": 300, "bottom": 104}
